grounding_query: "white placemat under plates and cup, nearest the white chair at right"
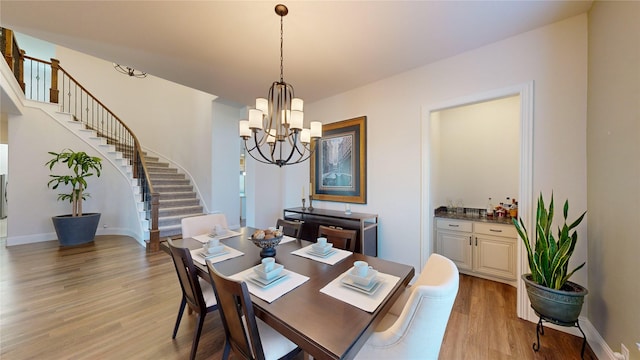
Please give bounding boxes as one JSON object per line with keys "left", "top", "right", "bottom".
{"left": 320, "top": 269, "right": 400, "bottom": 312}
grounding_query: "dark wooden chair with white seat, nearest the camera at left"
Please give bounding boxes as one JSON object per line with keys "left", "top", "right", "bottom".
{"left": 207, "top": 260, "right": 301, "bottom": 360}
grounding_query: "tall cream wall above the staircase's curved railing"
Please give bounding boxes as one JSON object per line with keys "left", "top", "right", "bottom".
{"left": 56, "top": 47, "right": 220, "bottom": 210}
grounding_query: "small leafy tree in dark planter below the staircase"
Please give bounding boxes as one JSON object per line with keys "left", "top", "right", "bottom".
{"left": 45, "top": 149, "right": 102, "bottom": 246}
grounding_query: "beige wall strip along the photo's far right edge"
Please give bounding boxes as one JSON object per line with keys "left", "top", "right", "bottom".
{"left": 587, "top": 1, "right": 640, "bottom": 360}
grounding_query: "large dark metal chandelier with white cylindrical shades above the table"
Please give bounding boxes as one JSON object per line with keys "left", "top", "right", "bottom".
{"left": 240, "top": 4, "right": 322, "bottom": 167}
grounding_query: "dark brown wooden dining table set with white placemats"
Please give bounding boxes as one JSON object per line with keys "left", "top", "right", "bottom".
{"left": 173, "top": 227, "right": 415, "bottom": 359}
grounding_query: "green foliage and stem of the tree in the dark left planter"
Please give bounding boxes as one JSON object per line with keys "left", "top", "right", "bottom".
{"left": 45, "top": 149, "right": 102, "bottom": 216}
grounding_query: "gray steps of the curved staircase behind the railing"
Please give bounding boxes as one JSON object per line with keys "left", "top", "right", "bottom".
{"left": 145, "top": 154, "right": 203, "bottom": 240}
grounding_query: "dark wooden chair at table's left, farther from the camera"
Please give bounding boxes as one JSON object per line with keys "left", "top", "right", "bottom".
{"left": 167, "top": 239, "right": 218, "bottom": 359}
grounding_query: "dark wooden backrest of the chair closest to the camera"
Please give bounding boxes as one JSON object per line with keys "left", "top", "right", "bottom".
{"left": 207, "top": 261, "right": 265, "bottom": 360}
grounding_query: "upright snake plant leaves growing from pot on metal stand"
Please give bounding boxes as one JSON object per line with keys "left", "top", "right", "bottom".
{"left": 513, "top": 193, "right": 587, "bottom": 289}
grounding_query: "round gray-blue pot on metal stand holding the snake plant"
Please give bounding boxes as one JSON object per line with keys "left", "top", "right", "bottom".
{"left": 522, "top": 274, "right": 588, "bottom": 326}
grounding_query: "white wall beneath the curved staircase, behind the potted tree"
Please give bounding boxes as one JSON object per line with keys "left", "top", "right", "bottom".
{"left": 7, "top": 107, "right": 142, "bottom": 246}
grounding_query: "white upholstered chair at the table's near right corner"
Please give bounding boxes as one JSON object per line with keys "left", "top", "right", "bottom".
{"left": 355, "top": 254, "right": 459, "bottom": 359}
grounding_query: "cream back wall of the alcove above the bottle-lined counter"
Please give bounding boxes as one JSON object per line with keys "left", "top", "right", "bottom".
{"left": 431, "top": 96, "right": 520, "bottom": 209}
